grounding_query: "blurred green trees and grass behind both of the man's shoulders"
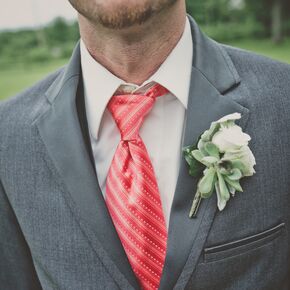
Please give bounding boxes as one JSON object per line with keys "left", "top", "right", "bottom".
{"left": 0, "top": 0, "right": 290, "bottom": 99}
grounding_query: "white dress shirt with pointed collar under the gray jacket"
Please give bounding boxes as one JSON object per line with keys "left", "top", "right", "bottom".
{"left": 81, "top": 19, "right": 192, "bottom": 226}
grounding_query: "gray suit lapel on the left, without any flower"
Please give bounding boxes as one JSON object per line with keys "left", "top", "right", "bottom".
{"left": 37, "top": 46, "right": 138, "bottom": 289}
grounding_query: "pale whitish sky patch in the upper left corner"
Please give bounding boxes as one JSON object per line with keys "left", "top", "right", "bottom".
{"left": 0, "top": 0, "right": 76, "bottom": 30}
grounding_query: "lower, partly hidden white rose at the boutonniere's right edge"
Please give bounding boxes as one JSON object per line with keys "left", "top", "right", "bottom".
{"left": 222, "top": 146, "right": 256, "bottom": 176}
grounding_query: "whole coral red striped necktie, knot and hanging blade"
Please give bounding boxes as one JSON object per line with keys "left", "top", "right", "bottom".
{"left": 106, "top": 84, "right": 168, "bottom": 290}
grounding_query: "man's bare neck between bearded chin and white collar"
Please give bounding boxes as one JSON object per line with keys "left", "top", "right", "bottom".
{"left": 79, "top": 1, "right": 186, "bottom": 85}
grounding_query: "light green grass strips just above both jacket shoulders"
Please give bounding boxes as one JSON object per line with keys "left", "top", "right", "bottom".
{"left": 0, "top": 38, "right": 290, "bottom": 100}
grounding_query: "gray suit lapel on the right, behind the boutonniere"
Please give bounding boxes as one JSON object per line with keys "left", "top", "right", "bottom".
{"left": 160, "top": 19, "right": 248, "bottom": 289}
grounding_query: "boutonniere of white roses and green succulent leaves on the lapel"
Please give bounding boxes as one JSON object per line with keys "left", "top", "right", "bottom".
{"left": 183, "top": 113, "right": 256, "bottom": 218}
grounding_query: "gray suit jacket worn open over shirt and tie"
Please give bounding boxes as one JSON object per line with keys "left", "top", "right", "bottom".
{"left": 0, "top": 19, "right": 290, "bottom": 290}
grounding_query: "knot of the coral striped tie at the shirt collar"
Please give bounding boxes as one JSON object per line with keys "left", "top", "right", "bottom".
{"left": 108, "top": 84, "right": 168, "bottom": 141}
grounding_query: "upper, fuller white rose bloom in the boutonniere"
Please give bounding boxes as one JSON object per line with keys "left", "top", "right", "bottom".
{"left": 212, "top": 124, "right": 251, "bottom": 153}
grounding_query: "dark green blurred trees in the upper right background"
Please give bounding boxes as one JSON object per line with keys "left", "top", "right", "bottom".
{"left": 186, "top": 0, "right": 290, "bottom": 43}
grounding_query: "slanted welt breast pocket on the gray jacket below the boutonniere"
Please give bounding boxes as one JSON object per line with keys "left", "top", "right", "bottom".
{"left": 204, "top": 223, "right": 285, "bottom": 263}
